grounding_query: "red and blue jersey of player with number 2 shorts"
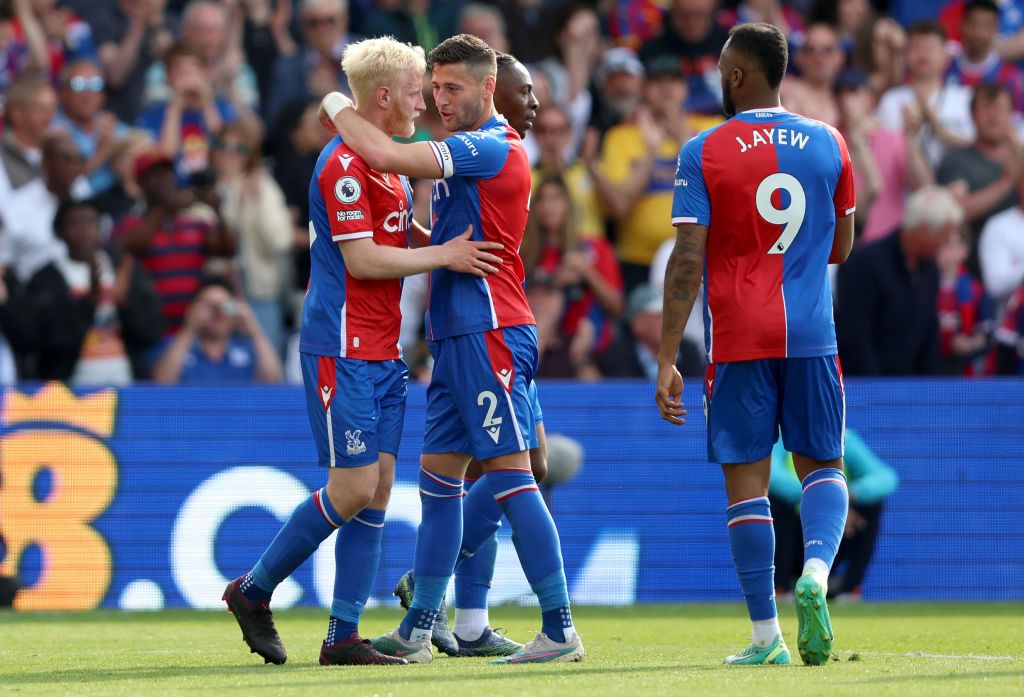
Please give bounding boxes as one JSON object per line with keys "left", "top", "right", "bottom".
{"left": 427, "top": 116, "right": 536, "bottom": 341}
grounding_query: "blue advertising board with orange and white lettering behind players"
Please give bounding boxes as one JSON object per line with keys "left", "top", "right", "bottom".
{"left": 0, "top": 380, "right": 1024, "bottom": 609}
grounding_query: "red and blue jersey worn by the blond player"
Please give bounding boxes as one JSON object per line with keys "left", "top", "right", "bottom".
{"left": 299, "top": 136, "right": 413, "bottom": 360}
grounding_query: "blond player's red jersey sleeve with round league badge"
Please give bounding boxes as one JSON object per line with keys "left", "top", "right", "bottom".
{"left": 319, "top": 150, "right": 374, "bottom": 242}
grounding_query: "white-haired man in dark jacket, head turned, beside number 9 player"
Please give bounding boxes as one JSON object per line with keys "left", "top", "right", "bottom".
{"left": 836, "top": 186, "right": 964, "bottom": 376}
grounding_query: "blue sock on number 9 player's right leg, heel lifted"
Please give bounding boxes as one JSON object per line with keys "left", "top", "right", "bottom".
{"left": 800, "top": 468, "right": 849, "bottom": 576}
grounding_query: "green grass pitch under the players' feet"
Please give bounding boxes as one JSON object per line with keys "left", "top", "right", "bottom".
{"left": 0, "top": 604, "right": 1024, "bottom": 697}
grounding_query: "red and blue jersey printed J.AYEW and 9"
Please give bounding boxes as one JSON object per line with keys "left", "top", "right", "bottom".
{"left": 672, "top": 107, "right": 855, "bottom": 363}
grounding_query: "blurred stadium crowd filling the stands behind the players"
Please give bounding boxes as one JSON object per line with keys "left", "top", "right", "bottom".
{"left": 0, "top": 0, "right": 1024, "bottom": 385}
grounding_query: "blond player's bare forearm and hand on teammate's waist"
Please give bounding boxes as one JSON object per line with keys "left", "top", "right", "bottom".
{"left": 338, "top": 225, "right": 503, "bottom": 280}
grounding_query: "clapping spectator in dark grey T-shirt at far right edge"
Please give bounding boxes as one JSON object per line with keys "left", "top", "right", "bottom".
{"left": 936, "top": 85, "right": 1022, "bottom": 271}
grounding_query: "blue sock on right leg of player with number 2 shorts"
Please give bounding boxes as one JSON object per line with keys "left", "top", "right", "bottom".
{"left": 486, "top": 470, "right": 575, "bottom": 642}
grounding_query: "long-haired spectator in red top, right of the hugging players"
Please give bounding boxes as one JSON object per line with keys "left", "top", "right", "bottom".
{"left": 521, "top": 176, "right": 623, "bottom": 350}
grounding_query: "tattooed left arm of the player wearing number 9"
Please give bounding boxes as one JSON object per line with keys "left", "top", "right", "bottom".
{"left": 654, "top": 223, "right": 708, "bottom": 426}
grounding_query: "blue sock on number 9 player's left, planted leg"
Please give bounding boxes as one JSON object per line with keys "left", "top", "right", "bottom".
{"left": 726, "top": 496, "right": 776, "bottom": 622}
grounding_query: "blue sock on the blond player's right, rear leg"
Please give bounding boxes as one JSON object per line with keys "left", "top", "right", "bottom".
{"left": 327, "top": 509, "right": 384, "bottom": 645}
